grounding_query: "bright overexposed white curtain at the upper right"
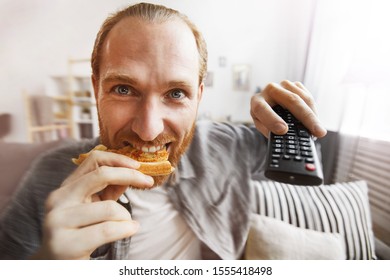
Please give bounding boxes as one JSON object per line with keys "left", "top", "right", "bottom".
{"left": 304, "top": 0, "right": 390, "bottom": 141}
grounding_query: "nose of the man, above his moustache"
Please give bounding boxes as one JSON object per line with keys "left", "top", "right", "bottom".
{"left": 132, "top": 99, "right": 164, "bottom": 141}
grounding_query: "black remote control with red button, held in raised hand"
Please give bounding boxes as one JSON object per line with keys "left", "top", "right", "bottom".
{"left": 265, "top": 105, "right": 323, "bottom": 186}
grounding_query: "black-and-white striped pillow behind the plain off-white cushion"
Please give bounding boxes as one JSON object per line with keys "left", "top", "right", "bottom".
{"left": 254, "top": 181, "right": 376, "bottom": 260}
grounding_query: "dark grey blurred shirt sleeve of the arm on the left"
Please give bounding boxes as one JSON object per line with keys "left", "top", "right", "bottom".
{"left": 0, "top": 143, "right": 88, "bottom": 259}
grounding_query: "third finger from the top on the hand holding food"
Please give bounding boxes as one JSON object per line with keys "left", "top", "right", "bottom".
{"left": 46, "top": 200, "right": 132, "bottom": 229}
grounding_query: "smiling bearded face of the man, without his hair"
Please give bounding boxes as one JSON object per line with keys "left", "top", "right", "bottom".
{"left": 93, "top": 18, "right": 203, "bottom": 184}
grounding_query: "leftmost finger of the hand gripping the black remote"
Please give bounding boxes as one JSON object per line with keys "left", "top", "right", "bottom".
{"left": 250, "top": 95, "right": 288, "bottom": 137}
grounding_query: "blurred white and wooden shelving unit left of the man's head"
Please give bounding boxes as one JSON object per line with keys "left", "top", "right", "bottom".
{"left": 33, "top": 58, "right": 99, "bottom": 141}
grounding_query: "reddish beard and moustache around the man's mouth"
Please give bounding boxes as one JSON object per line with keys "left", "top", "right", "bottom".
{"left": 99, "top": 112, "right": 196, "bottom": 187}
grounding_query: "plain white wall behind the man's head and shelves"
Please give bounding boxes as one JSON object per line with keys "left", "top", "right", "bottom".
{"left": 0, "top": 0, "right": 313, "bottom": 142}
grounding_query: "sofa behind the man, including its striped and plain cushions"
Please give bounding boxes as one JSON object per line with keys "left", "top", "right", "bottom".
{"left": 0, "top": 135, "right": 390, "bottom": 259}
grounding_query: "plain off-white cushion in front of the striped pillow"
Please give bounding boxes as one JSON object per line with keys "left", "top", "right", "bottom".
{"left": 244, "top": 214, "right": 346, "bottom": 260}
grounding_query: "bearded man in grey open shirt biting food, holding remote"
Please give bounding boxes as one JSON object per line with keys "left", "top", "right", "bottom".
{"left": 0, "top": 3, "right": 326, "bottom": 259}
